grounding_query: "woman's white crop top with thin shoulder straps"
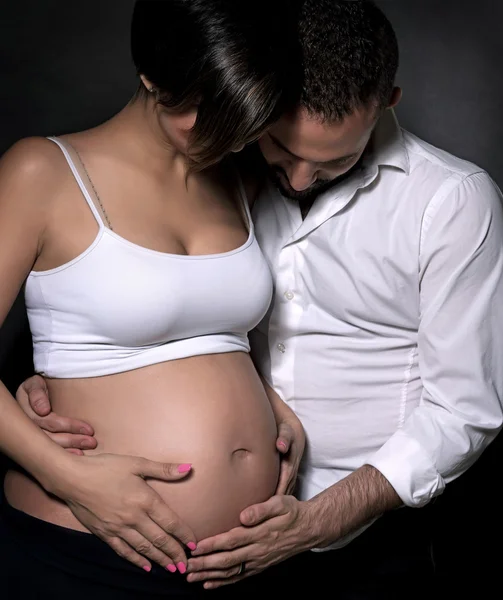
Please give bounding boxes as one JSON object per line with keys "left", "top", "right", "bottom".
{"left": 25, "top": 138, "right": 272, "bottom": 378}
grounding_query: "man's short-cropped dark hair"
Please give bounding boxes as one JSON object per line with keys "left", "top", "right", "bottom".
{"left": 299, "top": 0, "right": 399, "bottom": 121}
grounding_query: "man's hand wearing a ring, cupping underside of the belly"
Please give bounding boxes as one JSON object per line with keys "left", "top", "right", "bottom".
{"left": 187, "top": 496, "right": 318, "bottom": 589}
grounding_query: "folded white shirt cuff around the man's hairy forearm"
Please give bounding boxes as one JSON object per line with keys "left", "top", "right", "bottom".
{"left": 365, "top": 431, "right": 445, "bottom": 507}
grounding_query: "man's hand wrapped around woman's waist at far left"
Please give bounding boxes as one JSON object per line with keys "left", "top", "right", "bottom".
{"left": 16, "top": 375, "right": 97, "bottom": 455}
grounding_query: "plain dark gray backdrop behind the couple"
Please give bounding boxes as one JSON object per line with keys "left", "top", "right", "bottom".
{"left": 0, "top": 0, "right": 503, "bottom": 598}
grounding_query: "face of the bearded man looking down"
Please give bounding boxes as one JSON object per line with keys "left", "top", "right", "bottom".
{"left": 258, "top": 107, "right": 377, "bottom": 201}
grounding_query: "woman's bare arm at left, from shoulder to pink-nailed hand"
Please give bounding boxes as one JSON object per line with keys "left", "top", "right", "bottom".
{"left": 0, "top": 138, "right": 195, "bottom": 572}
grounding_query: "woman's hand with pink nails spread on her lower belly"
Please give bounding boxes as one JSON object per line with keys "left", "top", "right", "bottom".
{"left": 45, "top": 454, "right": 196, "bottom": 573}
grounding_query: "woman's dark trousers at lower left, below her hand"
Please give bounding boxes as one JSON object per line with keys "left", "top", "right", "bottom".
{"left": 0, "top": 501, "right": 232, "bottom": 600}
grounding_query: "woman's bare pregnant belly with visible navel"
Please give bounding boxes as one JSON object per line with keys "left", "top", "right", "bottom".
{"left": 5, "top": 352, "right": 279, "bottom": 539}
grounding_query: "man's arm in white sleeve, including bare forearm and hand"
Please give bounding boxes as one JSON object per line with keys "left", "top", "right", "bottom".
{"left": 189, "top": 173, "right": 503, "bottom": 588}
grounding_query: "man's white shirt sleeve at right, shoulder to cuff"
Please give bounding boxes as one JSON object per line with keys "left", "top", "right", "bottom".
{"left": 368, "top": 172, "right": 503, "bottom": 506}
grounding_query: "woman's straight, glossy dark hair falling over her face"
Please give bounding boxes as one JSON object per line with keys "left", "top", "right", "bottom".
{"left": 131, "top": 0, "right": 300, "bottom": 170}
